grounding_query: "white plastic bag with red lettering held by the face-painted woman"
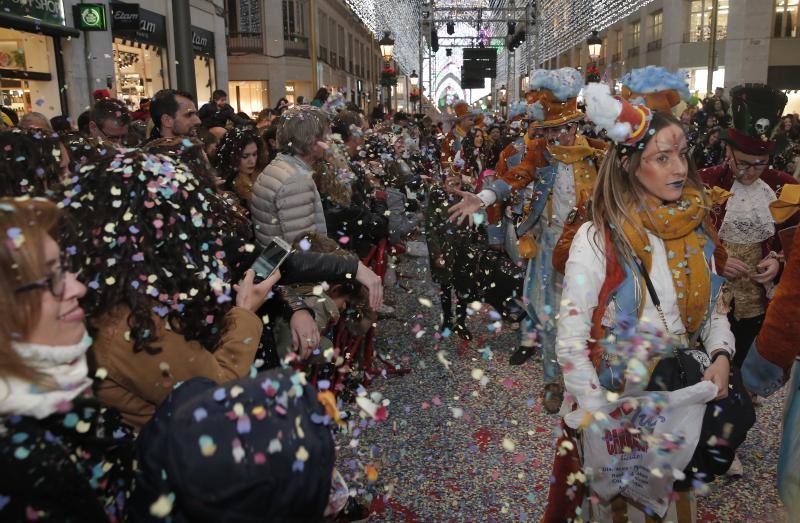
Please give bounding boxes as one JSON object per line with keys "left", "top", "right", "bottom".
{"left": 576, "top": 381, "right": 717, "bottom": 517}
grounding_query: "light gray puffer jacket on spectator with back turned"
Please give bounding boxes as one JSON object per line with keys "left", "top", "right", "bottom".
{"left": 250, "top": 154, "right": 328, "bottom": 245}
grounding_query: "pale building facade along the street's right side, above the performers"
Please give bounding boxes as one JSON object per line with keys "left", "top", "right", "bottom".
{"left": 516, "top": 0, "right": 800, "bottom": 112}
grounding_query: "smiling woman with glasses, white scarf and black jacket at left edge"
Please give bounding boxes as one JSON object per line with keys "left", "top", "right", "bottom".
{"left": 0, "top": 198, "right": 133, "bottom": 521}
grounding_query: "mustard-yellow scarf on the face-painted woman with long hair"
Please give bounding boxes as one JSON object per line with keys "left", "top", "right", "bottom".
{"left": 622, "top": 187, "right": 711, "bottom": 334}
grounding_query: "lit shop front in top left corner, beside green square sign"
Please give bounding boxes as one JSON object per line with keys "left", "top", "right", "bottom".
{"left": 0, "top": 0, "right": 81, "bottom": 118}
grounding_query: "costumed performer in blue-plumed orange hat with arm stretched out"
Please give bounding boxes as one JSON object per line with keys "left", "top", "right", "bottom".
{"left": 450, "top": 68, "right": 604, "bottom": 413}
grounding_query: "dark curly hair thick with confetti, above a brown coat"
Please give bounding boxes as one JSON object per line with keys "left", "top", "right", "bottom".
{"left": 62, "top": 149, "right": 241, "bottom": 354}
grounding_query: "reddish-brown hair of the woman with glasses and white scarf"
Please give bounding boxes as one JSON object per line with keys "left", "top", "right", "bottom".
{"left": 0, "top": 198, "right": 61, "bottom": 386}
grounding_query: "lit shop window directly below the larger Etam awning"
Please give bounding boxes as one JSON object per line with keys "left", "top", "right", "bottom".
{"left": 114, "top": 38, "right": 166, "bottom": 110}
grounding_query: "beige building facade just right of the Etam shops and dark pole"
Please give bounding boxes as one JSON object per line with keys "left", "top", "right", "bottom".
{"left": 226, "top": 0, "right": 390, "bottom": 114}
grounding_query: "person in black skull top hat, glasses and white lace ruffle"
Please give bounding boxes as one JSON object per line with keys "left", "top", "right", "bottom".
{"left": 699, "top": 84, "right": 797, "bottom": 372}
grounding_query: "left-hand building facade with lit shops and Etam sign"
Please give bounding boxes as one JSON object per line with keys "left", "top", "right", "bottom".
{"left": 0, "top": 0, "right": 228, "bottom": 121}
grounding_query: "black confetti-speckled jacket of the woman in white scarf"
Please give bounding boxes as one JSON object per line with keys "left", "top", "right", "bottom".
{"left": 0, "top": 397, "right": 134, "bottom": 523}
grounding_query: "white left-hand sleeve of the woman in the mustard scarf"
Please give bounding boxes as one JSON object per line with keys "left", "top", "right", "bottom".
{"left": 556, "top": 222, "right": 606, "bottom": 411}
